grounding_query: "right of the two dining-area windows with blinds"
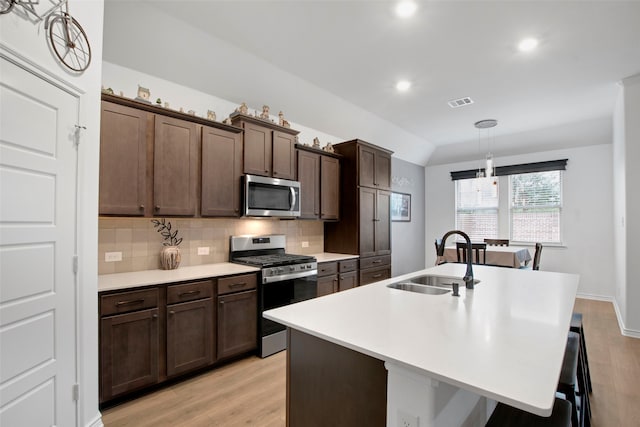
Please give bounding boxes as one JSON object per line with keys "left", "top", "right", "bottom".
{"left": 509, "top": 170, "right": 562, "bottom": 243}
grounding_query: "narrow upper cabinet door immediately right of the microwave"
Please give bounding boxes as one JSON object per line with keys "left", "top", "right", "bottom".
{"left": 298, "top": 150, "right": 321, "bottom": 219}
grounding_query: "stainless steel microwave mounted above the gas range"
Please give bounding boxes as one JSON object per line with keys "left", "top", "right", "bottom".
{"left": 244, "top": 175, "right": 300, "bottom": 218}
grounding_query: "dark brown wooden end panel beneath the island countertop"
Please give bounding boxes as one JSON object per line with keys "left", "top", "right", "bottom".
{"left": 287, "top": 329, "right": 387, "bottom": 427}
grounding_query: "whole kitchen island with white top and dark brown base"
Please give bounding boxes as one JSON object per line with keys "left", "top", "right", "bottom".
{"left": 264, "top": 264, "right": 578, "bottom": 427}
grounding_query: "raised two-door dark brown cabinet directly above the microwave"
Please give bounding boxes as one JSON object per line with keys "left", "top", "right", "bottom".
{"left": 230, "top": 113, "right": 299, "bottom": 180}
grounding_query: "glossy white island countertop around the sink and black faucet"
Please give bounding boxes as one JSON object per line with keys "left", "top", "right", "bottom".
{"left": 264, "top": 264, "right": 579, "bottom": 415}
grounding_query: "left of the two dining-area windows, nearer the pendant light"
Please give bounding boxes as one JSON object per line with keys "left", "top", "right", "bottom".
{"left": 456, "top": 178, "right": 499, "bottom": 241}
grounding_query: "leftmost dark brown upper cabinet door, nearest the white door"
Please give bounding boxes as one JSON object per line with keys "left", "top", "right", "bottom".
{"left": 99, "top": 101, "right": 147, "bottom": 215}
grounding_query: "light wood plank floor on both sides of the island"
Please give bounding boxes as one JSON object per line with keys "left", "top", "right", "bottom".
{"left": 102, "top": 299, "right": 640, "bottom": 427}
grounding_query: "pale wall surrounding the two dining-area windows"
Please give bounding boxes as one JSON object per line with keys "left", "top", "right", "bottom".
{"left": 425, "top": 144, "right": 615, "bottom": 299}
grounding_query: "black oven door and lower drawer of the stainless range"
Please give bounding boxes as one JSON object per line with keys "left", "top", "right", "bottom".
{"left": 259, "top": 274, "right": 318, "bottom": 357}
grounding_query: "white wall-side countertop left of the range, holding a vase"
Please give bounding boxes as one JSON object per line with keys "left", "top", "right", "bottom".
{"left": 98, "top": 262, "right": 260, "bottom": 292}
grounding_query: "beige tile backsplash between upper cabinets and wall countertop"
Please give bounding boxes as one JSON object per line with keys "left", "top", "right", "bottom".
{"left": 98, "top": 217, "right": 324, "bottom": 274}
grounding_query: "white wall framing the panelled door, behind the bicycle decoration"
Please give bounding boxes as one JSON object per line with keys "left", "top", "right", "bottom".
{"left": 0, "top": 0, "right": 104, "bottom": 426}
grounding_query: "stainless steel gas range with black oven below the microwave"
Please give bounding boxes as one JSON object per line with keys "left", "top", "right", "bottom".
{"left": 229, "top": 234, "right": 318, "bottom": 357}
